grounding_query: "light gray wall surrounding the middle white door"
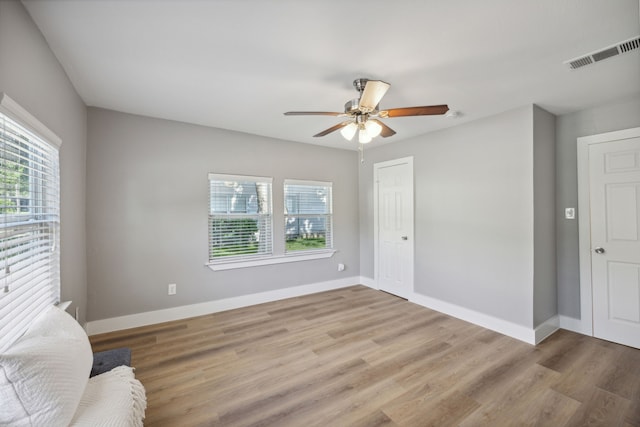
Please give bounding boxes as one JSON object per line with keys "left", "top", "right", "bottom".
{"left": 360, "top": 106, "right": 534, "bottom": 327}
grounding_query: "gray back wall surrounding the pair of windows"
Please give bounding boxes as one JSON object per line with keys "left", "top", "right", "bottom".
{"left": 87, "top": 108, "right": 360, "bottom": 320}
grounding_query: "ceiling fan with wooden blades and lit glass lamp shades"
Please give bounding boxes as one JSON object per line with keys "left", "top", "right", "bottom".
{"left": 284, "top": 78, "right": 449, "bottom": 144}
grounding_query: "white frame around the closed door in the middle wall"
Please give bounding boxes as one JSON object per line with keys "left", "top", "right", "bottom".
{"left": 373, "top": 156, "right": 416, "bottom": 299}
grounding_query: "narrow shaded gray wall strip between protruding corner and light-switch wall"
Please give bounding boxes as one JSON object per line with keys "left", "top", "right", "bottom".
{"left": 533, "top": 106, "right": 558, "bottom": 328}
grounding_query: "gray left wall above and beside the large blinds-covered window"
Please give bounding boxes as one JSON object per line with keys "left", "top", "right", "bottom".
{"left": 0, "top": 0, "right": 87, "bottom": 322}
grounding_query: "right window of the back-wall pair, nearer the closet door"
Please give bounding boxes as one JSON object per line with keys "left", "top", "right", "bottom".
{"left": 284, "top": 180, "right": 333, "bottom": 253}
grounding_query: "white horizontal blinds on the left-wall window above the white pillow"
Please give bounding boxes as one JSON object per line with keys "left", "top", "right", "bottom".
{"left": 0, "top": 94, "right": 60, "bottom": 351}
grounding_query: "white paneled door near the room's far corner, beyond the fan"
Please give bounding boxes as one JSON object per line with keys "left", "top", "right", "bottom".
{"left": 374, "top": 158, "right": 414, "bottom": 298}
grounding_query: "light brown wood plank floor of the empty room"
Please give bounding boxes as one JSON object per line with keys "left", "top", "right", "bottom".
{"left": 91, "top": 286, "right": 640, "bottom": 427}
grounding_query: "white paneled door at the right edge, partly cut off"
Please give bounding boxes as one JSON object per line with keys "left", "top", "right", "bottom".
{"left": 589, "top": 138, "right": 640, "bottom": 348}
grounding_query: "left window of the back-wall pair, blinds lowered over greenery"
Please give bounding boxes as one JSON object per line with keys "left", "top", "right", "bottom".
{"left": 209, "top": 174, "right": 273, "bottom": 263}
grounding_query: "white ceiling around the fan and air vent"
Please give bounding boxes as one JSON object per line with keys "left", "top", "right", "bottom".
{"left": 23, "top": 0, "right": 640, "bottom": 149}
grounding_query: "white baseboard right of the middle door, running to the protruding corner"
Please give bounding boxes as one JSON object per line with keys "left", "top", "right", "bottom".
{"left": 409, "top": 292, "right": 536, "bottom": 345}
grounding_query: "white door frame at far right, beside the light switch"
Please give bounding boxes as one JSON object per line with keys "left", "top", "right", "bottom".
{"left": 576, "top": 127, "right": 640, "bottom": 336}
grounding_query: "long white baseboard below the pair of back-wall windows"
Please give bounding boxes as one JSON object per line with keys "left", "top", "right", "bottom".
{"left": 85, "top": 276, "right": 361, "bottom": 335}
